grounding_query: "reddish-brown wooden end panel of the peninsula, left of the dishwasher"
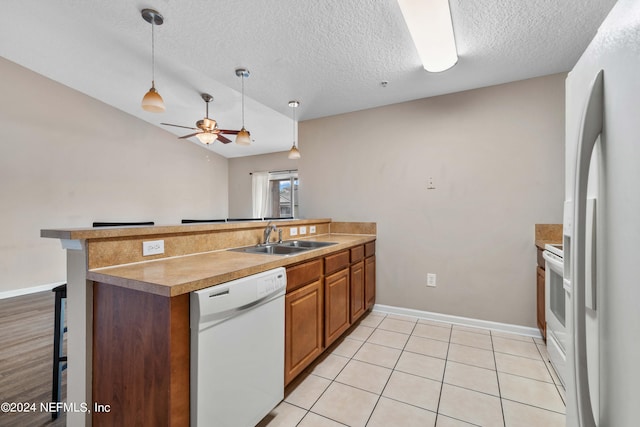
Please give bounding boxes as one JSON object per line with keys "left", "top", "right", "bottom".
{"left": 91, "top": 282, "right": 190, "bottom": 427}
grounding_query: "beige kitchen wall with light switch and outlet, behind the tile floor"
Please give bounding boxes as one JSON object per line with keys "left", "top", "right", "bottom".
{"left": 299, "top": 74, "right": 565, "bottom": 327}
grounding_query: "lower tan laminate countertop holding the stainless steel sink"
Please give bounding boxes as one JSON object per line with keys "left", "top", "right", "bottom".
{"left": 87, "top": 234, "right": 376, "bottom": 297}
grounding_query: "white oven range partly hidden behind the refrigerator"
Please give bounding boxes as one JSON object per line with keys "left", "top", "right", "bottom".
{"left": 542, "top": 245, "right": 571, "bottom": 385}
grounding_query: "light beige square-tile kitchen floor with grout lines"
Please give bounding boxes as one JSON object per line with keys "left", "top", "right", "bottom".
{"left": 259, "top": 312, "right": 565, "bottom": 427}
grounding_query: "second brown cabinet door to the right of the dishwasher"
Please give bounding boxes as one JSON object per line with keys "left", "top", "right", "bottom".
{"left": 324, "top": 268, "right": 351, "bottom": 347}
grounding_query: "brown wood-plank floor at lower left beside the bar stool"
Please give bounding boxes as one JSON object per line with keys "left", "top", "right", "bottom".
{"left": 0, "top": 291, "right": 67, "bottom": 427}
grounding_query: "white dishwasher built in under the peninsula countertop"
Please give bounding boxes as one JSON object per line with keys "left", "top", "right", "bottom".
{"left": 191, "top": 267, "right": 287, "bottom": 427}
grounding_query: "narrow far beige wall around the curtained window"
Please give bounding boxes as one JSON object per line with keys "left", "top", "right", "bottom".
{"left": 229, "top": 151, "right": 302, "bottom": 218}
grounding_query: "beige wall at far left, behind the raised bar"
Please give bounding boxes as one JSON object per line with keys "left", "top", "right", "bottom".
{"left": 0, "top": 58, "right": 228, "bottom": 296}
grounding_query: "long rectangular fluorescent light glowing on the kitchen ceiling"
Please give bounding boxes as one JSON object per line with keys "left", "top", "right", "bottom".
{"left": 398, "top": 0, "right": 458, "bottom": 73}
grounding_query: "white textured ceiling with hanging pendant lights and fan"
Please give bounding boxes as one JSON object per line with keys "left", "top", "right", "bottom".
{"left": 0, "top": 0, "right": 615, "bottom": 157}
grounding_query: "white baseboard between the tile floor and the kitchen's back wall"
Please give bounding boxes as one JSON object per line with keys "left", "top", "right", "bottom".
{"left": 373, "top": 304, "right": 542, "bottom": 338}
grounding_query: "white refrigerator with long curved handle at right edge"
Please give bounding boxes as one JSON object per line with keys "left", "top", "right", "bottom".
{"left": 563, "top": 0, "right": 640, "bottom": 427}
